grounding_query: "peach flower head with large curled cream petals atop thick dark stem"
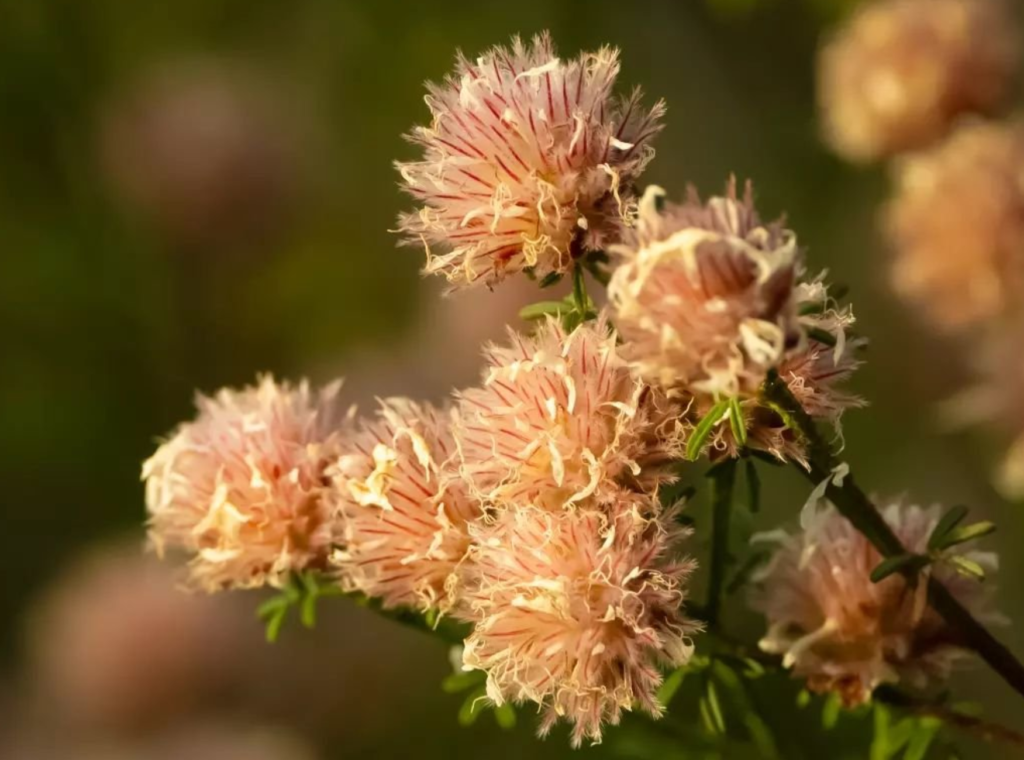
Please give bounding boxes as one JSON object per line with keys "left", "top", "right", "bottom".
{"left": 608, "top": 180, "right": 864, "bottom": 462}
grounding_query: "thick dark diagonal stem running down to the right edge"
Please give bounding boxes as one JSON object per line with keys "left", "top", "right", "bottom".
{"left": 763, "top": 373, "right": 1024, "bottom": 696}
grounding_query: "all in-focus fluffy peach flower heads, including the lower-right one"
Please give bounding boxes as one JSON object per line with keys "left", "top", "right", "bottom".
{"left": 143, "top": 28, "right": 1010, "bottom": 746}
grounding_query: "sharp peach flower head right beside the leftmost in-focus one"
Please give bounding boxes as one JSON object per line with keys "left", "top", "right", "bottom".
{"left": 329, "top": 398, "right": 480, "bottom": 610}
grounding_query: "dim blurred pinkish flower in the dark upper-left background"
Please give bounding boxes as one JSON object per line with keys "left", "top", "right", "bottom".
{"left": 98, "top": 57, "right": 310, "bottom": 251}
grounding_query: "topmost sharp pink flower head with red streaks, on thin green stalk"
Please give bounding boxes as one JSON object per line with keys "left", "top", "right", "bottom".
{"left": 396, "top": 34, "right": 665, "bottom": 287}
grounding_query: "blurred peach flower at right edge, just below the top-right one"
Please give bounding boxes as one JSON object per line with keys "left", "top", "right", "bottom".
{"left": 887, "top": 120, "right": 1024, "bottom": 331}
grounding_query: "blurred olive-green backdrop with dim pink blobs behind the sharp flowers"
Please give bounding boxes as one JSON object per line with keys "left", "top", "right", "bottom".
{"left": 0, "top": 0, "right": 1024, "bottom": 760}
